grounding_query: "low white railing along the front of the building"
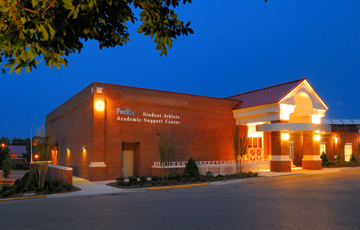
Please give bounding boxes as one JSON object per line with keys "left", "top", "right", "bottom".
{"left": 152, "top": 160, "right": 270, "bottom": 175}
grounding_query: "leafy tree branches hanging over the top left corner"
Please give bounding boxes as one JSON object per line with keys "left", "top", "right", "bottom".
{"left": 0, "top": 0, "right": 193, "bottom": 74}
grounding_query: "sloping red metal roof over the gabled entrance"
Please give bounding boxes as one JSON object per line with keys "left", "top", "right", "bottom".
{"left": 227, "top": 78, "right": 306, "bottom": 110}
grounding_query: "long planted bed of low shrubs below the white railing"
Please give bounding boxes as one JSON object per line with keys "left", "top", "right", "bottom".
{"left": 107, "top": 172, "right": 258, "bottom": 189}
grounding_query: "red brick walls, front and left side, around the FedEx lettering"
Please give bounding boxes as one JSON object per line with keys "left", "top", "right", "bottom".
{"left": 46, "top": 83, "right": 236, "bottom": 180}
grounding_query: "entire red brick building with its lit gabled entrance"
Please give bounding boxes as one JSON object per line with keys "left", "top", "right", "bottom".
{"left": 46, "top": 79, "right": 358, "bottom": 181}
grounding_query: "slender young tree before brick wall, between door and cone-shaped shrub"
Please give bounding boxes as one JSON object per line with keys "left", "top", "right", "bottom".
{"left": 159, "top": 131, "right": 178, "bottom": 180}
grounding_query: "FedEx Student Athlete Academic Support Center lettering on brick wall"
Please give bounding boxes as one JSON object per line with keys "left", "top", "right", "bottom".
{"left": 116, "top": 108, "right": 180, "bottom": 125}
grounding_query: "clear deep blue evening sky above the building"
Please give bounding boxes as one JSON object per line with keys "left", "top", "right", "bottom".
{"left": 0, "top": 0, "right": 360, "bottom": 138}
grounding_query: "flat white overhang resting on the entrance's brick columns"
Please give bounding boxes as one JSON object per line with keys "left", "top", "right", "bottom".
{"left": 256, "top": 123, "right": 331, "bottom": 133}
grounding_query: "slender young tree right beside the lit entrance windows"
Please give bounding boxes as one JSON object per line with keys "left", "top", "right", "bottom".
{"left": 233, "top": 125, "right": 247, "bottom": 174}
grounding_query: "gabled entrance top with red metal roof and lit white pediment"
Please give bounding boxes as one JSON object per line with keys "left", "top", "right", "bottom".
{"left": 228, "top": 78, "right": 328, "bottom": 126}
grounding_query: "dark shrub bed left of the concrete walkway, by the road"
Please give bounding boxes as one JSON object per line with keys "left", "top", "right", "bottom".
{"left": 0, "top": 172, "right": 81, "bottom": 200}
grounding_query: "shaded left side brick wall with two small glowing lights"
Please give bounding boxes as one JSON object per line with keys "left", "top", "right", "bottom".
{"left": 46, "top": 86, "right": 94, "bottom": 179}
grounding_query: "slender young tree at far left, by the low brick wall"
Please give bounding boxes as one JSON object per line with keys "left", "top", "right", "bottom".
{"left": 34, "top": 126, "right": 55, "bottom": 188}
